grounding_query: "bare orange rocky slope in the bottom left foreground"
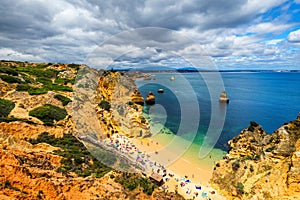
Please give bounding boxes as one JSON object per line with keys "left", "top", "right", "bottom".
{"left": 0, "top": 150, "right": 180, "bottom": 200}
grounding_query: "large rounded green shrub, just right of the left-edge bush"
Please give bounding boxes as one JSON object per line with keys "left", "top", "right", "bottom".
{"left": 29, "top": 104, "right": 68, "bottom": 125}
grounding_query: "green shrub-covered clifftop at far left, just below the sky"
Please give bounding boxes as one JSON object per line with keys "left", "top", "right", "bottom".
{"left": 0, "top": 61, "right": 80, "bottom": 95}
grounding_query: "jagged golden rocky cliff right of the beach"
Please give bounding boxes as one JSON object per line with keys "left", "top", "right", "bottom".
{"left": 211, "top": 118, "right": 300, "bottom": 199}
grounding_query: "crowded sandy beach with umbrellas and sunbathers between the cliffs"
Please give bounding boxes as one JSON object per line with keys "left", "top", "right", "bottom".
{"left": 106, "top": 131, "right": 224, "bottom": 199}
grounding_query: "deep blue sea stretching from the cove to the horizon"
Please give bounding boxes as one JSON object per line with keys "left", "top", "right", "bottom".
{"left": 136, "top": 72, "right": 300, "bottom": 150}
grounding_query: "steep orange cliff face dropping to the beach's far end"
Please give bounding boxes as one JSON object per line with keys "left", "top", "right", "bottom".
{"left": 96, "top": 71, "right": 150, "bottom": 137}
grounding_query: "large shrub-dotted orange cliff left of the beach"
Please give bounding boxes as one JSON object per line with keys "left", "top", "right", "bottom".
{"left": 0, "top": 61, "right": 181, "bottom": 200}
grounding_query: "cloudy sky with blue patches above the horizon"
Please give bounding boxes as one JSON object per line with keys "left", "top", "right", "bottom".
{"left": 0, "top": 0, "right": 300, "bottom": 69}
